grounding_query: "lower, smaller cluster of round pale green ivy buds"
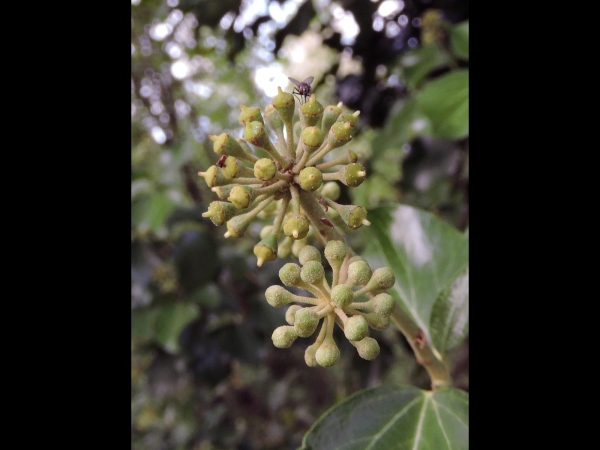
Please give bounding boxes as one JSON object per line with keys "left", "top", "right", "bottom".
{"left": 265, "top": 241, "right": 396, "bottom": 367}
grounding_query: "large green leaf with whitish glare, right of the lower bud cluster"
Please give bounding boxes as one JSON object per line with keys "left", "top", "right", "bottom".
{"left": 365, "top": 205, "right": 469, "bottom": 351}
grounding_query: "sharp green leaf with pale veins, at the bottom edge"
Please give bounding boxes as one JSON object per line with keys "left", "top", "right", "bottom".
{"left": 301, "top": 386, "right": 469, "bottom": 450}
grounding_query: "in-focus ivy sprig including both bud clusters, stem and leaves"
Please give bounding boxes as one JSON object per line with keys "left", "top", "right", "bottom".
{"left": 199, "top": 83, "right": 468, "bottom": 449}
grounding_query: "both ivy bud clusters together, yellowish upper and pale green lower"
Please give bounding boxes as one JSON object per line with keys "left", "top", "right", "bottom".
{"left": 198, "top": 88, "right": 395, "bottom": 367}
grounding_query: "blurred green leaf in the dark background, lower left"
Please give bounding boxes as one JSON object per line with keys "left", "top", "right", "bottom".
{"left": 155, "top": 302, "right": 200, "bottom": 353}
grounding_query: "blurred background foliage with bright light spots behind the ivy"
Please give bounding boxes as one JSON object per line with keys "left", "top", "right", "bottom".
{"left": 131, "top": 0, "right": 469, "bottom": 450}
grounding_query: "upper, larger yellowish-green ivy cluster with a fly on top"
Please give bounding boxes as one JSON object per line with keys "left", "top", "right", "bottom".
{"left": 198, "top": 88, "right": 370, "bottom": 266}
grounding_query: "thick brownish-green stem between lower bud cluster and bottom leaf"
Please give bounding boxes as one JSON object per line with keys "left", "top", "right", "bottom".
{"left": 391, "top": 305, "right": 450, "bottom": 391}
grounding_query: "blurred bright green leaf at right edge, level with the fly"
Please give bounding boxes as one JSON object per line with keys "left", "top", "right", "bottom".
{"left": 417, "top": 69, "right": 469, "bottom": 139}
